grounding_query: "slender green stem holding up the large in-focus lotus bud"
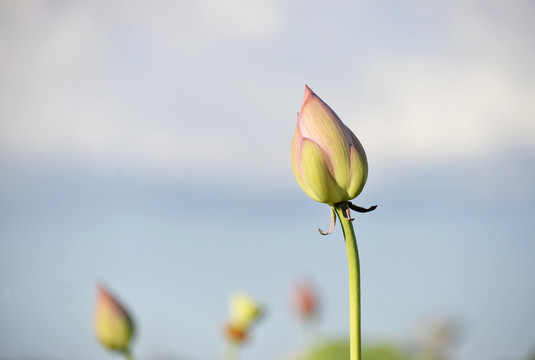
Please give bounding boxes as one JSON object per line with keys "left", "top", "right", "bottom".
{"left": 334, "top": 204, "right": 361, "bottom": 360}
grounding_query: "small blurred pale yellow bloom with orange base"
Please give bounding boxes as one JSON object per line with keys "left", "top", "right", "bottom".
{"left": 225, "top": 293, "right": 263, "bottom": 343}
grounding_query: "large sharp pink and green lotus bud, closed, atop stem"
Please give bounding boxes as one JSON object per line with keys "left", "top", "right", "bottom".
{"left": 291, "top": 85, "right": 368, "bottom": 205}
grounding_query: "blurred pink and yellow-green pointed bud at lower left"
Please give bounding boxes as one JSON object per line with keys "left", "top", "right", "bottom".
{"left": 94, "top": 285, "right": 134, "bottom": 353}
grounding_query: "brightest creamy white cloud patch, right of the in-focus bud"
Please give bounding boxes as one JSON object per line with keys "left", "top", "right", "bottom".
{"left": 354, "top": 61, "right": 535, "bottom": 166}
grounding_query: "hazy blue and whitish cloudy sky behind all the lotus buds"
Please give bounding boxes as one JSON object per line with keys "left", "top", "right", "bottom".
{"left": 0, "top": 0, "right": 535, "bottom": 360}
